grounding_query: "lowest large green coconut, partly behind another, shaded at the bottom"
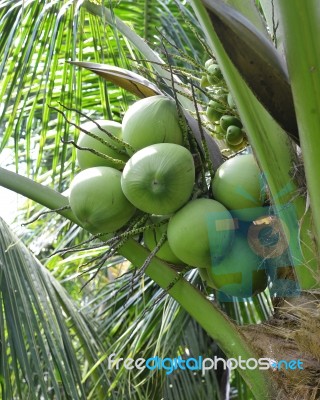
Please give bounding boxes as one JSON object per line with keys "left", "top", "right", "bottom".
{"left": 207, "top": 233, "right": 268, "bottom": 297}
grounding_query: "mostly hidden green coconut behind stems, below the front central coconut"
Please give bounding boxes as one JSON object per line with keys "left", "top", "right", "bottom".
{"left": 143, "top": 216, "right": 183, "bottom": 264}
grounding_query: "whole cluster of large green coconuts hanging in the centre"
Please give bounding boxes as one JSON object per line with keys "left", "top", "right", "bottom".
{"left": 69, "top": 95, "right": 267, "bottom": 297}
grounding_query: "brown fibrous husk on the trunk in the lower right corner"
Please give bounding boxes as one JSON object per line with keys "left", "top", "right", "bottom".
{"left": 240, "top": 291, "right": 320, "bottom": 400}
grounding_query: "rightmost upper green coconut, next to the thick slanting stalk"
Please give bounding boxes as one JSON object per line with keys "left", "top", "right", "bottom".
{"left": 212, "top": 154, "right": 265, "bottom": 221}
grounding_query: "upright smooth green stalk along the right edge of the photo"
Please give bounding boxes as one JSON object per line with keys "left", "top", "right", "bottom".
{"left": 277, "top": 0, "right": 320, "bottom": 278}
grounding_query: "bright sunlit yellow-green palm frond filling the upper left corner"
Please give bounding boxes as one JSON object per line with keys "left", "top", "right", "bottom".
{"left": 0, "top": 0, "right": 136, "bottom": 183}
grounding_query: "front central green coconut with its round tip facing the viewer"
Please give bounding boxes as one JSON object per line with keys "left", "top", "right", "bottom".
{"left": 121, "top": 143, "right": 195, "bottom": 215}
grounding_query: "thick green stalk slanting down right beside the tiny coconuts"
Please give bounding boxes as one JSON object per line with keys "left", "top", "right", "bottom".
{"left": 190, "top": 0, "right": 319, "bottom": 289}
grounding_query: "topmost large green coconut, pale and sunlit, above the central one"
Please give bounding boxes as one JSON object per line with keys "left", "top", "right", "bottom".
{"left": 122, "top": 95, "right": 183, "bottom": 155}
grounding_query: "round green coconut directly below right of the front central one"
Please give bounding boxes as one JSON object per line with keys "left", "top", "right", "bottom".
{"left": 167, "top": 198, "right": 234, "bottom": 268}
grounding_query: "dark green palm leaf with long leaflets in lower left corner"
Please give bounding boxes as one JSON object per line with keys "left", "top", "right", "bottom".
{"left": 0, "top": 220, "right": 107, "bottom": 399}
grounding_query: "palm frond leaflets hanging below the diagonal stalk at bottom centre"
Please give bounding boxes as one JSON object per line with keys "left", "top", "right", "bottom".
{"left": 79, "top": 271, "right": 226, "bottom": 400}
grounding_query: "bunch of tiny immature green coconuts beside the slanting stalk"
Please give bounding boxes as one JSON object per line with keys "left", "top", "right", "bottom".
{"left": 200, "top": 58, "right": 248, "bottom": 152}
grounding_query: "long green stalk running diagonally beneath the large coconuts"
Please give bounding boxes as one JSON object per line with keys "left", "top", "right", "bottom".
{"left": 0, "top": 168, "right": 274, "bottom": 400}
